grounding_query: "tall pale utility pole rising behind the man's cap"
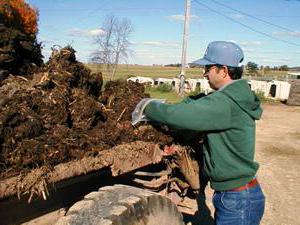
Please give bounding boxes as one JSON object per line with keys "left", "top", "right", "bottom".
{"left": 179, "top": 0, "right": 191, "bottom": 96}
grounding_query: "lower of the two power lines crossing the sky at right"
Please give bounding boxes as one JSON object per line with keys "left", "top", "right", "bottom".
{"left": 194, "top": 0, "right": 300, "bottom": 47}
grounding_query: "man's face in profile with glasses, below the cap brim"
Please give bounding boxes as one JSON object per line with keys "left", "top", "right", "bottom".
{"left": 203, "top": 65, "right": 223, "bottom": 90}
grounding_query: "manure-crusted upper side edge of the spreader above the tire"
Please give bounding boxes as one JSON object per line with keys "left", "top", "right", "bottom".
{"left": 0, "top": 141, "right": 162, "bottom": 202}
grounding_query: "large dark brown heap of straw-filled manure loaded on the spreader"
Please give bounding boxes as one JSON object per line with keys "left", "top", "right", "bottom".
{"left": 0, "top": 46, "right": 173, "bottom": 179}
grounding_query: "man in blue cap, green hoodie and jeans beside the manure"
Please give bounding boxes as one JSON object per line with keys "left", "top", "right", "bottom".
{"left": 135, "top": 41, "right": 265, "bottom": 225}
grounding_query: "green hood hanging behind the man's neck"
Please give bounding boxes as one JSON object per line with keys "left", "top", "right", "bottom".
{"left": 220, "top": 79, "right": 262, "bottom": 120}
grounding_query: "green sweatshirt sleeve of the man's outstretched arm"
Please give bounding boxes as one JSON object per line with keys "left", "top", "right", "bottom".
{"left": 144, "top": 93, "right": 231, "bottom": 131}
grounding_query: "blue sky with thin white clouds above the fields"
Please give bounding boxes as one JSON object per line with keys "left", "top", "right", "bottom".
{"left": 26, "top": 0, "right": 300, "bottom": 67}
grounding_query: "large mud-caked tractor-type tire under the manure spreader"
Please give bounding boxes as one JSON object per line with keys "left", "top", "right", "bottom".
{"left": 56, "top": 185, "right": 184, "bottom": 225}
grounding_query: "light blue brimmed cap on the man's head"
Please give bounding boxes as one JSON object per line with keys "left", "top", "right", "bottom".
{"left": 193, "top": 41, "right": 244, "bottom": 67}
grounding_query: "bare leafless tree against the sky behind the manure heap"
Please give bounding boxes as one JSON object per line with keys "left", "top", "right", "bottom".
{"left": 92, "top": 15, "right": 133, "bottom": 80}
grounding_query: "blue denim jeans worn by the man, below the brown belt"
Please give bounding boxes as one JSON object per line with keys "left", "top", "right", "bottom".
{"left": 213, "top": 184, "right": 265, "bottom": 225}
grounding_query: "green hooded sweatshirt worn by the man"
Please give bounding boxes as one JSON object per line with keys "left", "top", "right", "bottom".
{"left": 144, "top": 80, "right": 262, "bottom": 191}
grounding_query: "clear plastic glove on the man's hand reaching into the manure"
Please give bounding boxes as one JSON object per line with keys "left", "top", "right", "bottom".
{"left": 131, "top": 98, "right": 166, "bottom": 126}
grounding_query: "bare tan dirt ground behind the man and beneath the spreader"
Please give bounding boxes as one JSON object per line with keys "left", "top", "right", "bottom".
{"left": 183, "top": 104, "right": 300, "bottom": 225}
